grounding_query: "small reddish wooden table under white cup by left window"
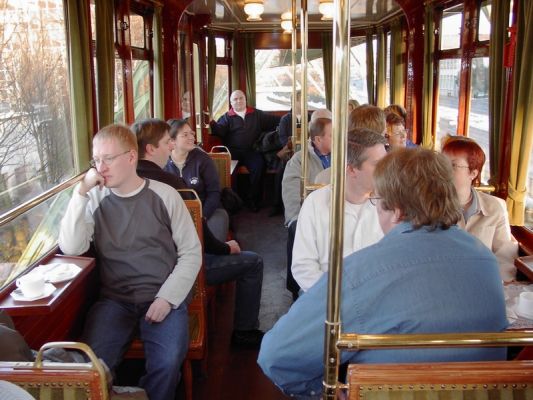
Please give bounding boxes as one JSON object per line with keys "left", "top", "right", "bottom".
{"left": 0, "top": 255, "right": 95, "bottom": 316}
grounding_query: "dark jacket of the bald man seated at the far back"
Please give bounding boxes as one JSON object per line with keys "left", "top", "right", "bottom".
{"left": 210, "top": 107, "right": 280, "bottom": 152}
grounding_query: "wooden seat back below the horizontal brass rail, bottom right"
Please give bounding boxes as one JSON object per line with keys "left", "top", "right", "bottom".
{"left": 347, "top": 361, "right": 533, "bottom": 400}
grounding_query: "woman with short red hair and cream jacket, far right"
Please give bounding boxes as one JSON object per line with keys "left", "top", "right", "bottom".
{"left": 442, "top": 137, "right": 518, "bottom": 282}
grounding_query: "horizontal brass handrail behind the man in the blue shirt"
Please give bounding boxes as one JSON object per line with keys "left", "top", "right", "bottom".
{"left": 337, "top": 331, "right": 533, "bottom": 351}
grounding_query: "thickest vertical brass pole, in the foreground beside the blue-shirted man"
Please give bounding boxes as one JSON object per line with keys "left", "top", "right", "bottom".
{"left": 323, "top": 0, "right": 350, "bottom": 400}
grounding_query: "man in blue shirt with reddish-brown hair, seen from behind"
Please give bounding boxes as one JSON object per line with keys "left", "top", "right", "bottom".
{"left": 258, "top": 148, "right": 507, "bottom": 397}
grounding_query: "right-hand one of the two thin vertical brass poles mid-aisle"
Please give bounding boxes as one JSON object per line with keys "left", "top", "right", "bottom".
{"left": 300, "top": 0, "right": 309, "bottom": 198}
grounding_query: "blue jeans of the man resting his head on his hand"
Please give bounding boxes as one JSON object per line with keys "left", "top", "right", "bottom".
{"left": 83, "top": 298, "right": 189, "bottom": 400}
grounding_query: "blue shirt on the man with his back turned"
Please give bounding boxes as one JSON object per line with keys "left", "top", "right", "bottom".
{"left": 258, "top": 222, "right": 507, "bottom": 396}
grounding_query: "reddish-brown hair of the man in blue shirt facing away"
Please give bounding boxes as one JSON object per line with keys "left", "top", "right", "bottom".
{"left": 374, "top": 147, "right": 461, "bottom": 229}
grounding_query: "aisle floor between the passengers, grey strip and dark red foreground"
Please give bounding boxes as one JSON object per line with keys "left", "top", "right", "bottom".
{"left": 189, "top": 208, "right": 292, "bottom": 400}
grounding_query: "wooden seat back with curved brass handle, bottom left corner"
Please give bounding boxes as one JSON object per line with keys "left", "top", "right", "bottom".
{"left": 0, "top": 342, "right": 109, "bottom": 400}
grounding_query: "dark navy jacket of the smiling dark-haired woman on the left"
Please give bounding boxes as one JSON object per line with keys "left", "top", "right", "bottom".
{"left": 165, "top": 147, "right": 221, "bottom": 219}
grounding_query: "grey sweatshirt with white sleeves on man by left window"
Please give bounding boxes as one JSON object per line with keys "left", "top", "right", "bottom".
{"left": 59, "top": 179, "right": 202, "bottom": 306}
